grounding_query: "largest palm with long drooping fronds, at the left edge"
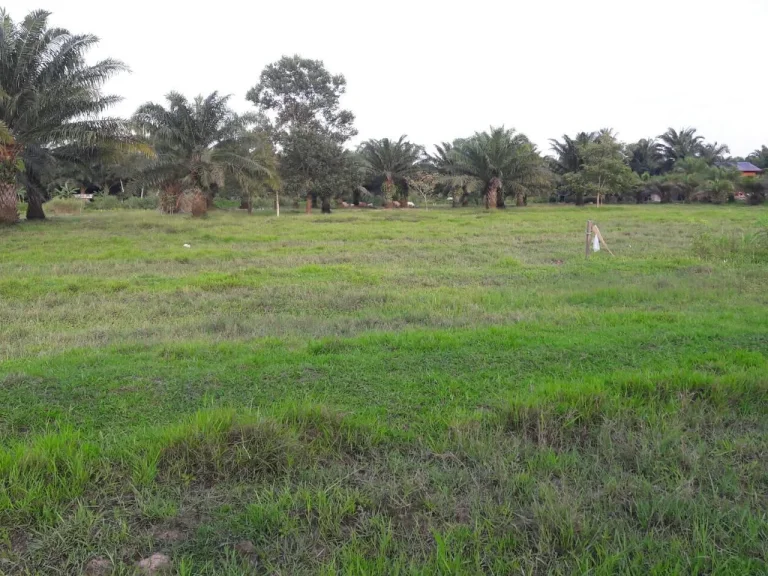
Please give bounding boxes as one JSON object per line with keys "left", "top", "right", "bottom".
{"left": 0, "top": 9, "right": 135, "bottom": 220}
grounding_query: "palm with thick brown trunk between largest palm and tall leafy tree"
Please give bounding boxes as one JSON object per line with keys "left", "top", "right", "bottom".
{"left": 133, "top": 92, "right": 269, "bottom": 211}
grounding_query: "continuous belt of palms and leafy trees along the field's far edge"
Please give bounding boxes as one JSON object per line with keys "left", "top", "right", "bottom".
{"left": 0, "top": 11, "right": 768, "bottom": 222}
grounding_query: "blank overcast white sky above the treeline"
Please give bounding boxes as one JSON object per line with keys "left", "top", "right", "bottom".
{"left": 6, "top": 0, "right": 768, "bottom": 155}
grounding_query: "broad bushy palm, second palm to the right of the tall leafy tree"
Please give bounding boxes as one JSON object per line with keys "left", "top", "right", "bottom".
{"left": 453, "top": 126, "right": 544, "bottom": 209}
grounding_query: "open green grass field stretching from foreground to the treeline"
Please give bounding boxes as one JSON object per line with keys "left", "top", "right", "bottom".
{"left": 0, "top": 205, "right": 768, "bottom": 575}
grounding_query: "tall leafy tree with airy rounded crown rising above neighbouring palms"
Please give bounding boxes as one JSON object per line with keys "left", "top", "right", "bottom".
{"left": 246, "top": 55, "right": 357, "bottom": 212}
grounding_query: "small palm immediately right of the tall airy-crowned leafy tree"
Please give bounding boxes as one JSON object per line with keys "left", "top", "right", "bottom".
{"left": 358, "top": 135, "right": 424, "bottom": 205}
